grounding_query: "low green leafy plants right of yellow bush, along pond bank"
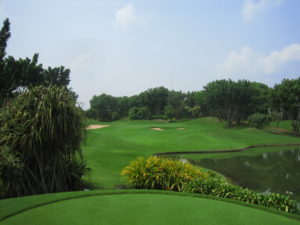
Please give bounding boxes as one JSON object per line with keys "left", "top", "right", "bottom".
{"left": 184, "top": 178, "right": 297, "bottom": 213}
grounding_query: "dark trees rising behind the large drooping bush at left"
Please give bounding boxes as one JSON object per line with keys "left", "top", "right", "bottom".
{"left": 0, "top": 19, "right": 70, "bottom": 106}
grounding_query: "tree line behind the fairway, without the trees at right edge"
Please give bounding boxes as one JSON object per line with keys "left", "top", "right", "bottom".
{"left": 87, "top": 80, "right": 270, "bottom": 126}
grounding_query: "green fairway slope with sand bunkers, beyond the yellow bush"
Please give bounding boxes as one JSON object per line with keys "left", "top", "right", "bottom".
{"left": 83, "top": 117, "right": 300, "bottom": 188}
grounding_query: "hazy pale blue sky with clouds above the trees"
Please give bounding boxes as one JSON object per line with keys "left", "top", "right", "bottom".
{"left": 0, "top": 0, "right": 300, "bottom": 108}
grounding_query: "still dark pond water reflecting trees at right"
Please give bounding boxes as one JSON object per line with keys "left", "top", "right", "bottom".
{"left": 190, "top": 149, "right": 300, "bottom": 205}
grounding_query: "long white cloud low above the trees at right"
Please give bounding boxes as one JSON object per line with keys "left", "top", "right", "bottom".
{"left": 217, "top": 44, "right": 300, "bottom": 75}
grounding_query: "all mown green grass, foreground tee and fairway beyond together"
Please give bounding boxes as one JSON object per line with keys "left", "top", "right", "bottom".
{"left": 0, "top": 117, "right": 300, "bottom": 225}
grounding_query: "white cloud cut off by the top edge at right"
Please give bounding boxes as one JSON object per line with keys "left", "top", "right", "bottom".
{"left": 242, "top": 0, "right": 282, "bottom": 21}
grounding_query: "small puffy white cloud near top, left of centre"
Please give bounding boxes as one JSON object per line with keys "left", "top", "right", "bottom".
{"left": 114, "top": 3, "right": 144, "bottom": 30}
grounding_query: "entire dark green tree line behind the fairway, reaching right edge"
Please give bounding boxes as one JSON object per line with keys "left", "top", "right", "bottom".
{"left": 87, "top": 78, "right": 300, "bottom": 133}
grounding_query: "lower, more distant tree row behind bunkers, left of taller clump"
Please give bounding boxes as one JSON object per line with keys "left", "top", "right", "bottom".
{"left": 87, "top": 87, "right": 201, "bottom": 121}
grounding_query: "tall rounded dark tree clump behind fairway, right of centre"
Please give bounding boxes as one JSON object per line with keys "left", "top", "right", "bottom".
{"left": 204, "top": 79, "right": 269, "bottom": 127}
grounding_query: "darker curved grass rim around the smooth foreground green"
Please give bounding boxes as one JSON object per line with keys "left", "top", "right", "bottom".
{"left": 0, "top": 189, "right": 300, "bottom": 222}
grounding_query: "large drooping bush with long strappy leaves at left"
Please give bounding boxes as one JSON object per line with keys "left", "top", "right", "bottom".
{"left": 0, "top": 86, "right": 88, "bottom": 196}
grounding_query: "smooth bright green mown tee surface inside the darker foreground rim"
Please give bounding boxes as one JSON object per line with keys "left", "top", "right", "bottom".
{"left": 0, "top": 192, "right": 299, "bottom": 225}
